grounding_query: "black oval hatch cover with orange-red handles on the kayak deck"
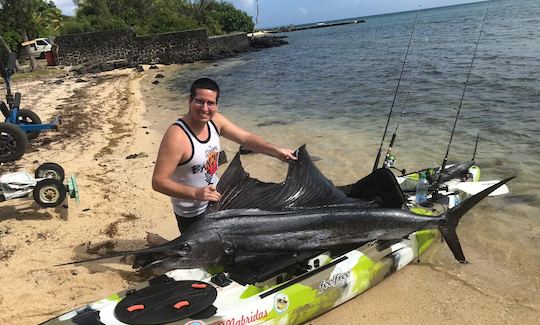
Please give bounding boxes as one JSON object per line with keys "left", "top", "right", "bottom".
{"left": 114, "top": 281, "right": 217, "bottom": 325}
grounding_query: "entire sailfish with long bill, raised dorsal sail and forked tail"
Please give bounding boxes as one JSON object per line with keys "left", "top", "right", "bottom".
{"left": 57, "top": 147, "right": 512, "bottom": 270}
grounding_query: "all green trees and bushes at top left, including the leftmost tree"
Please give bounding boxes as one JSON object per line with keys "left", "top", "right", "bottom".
{"left": 0, "top": 0, "right": 254, "bottom": 57}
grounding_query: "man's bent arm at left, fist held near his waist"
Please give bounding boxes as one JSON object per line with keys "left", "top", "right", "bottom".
{"left": 152, "top": 125, "right": 221, "bottom": 201}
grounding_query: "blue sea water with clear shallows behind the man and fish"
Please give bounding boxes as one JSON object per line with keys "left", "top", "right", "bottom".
{"left": 150, "top": 0, "right": 540, "bottom": 312}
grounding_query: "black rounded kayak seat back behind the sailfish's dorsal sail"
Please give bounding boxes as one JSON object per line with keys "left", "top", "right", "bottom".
{"left": 338, "top": 168, "right": 406, "bottom": 208}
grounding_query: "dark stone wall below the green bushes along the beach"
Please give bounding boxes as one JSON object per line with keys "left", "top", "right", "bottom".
{"left": 55, "top": 29, "right": 250, "bottom": 65}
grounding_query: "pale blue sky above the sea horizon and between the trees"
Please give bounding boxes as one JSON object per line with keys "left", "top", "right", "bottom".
{"left": 53, "top": 0, "right": 486, "bottom": 28}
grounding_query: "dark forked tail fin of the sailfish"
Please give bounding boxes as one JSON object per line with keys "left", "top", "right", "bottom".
{"left": 439, "top": 176, "right": 515, "bottom": 263}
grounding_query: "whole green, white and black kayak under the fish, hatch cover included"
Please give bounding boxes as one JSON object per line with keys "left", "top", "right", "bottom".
{"left": 44, "top": 230, "right": 439, "bottom": 325}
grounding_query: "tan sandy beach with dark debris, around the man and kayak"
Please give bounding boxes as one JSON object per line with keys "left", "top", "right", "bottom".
{"left": 0, "top": 66, "right": 540, "bottom": 324}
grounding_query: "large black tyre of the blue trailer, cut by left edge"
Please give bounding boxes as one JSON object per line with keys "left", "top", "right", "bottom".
{"left": 0, "top": 122, "right": 28, "bottom": 162}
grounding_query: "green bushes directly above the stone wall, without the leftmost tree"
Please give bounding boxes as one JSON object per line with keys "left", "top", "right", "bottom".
{"left": 61, "top": 0, "right": 253, "bottom": 35}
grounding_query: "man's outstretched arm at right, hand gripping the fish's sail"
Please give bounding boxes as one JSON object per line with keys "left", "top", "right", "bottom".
{"left": 213, "top": 113, "right": 297, "bottom": 161}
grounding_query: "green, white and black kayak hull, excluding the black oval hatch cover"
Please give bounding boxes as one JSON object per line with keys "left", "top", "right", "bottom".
{"left": 44, "top": 230, "right": 439, "bottom": 325}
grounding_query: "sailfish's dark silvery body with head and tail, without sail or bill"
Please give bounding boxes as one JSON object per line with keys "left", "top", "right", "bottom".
{"left": 132, "top": 171, "right": 510, "bottom": 269}
